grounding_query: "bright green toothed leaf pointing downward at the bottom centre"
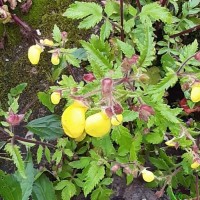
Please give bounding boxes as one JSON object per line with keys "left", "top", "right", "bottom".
{"left": 83, "top": 161, "right": 105, "bottom": 197}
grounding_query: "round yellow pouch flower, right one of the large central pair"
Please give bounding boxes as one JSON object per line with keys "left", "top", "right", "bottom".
{"left": 85, "top": 112, "right": 111, "bottom": 137}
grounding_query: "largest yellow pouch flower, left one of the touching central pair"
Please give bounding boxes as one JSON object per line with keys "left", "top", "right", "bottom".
{"left": 61, "top": 101, "right": 87, "bottom": 138}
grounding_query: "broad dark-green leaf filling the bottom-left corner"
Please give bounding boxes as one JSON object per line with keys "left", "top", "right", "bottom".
{"left": 0, "top": 170, "right": 22, "bottom": 200}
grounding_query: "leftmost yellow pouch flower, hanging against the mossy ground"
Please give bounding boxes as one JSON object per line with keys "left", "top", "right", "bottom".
{"left": 28, "top": 44, "right": 42, "bottom": 65}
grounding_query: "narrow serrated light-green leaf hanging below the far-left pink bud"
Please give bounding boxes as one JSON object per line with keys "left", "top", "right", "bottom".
{"left": 5, "top": 143, "right": 26, "bottom": 178}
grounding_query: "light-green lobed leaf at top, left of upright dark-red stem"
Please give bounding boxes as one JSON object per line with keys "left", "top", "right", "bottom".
{"left": 63, "top": 1, "right": 102, "bottom": 29}
